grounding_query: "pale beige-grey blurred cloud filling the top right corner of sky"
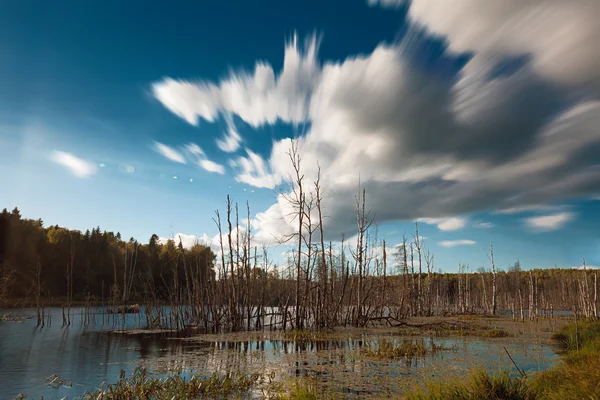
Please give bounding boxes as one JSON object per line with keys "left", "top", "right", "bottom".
{"left": 378, "top": 0, "right": 600, "bottom": 85}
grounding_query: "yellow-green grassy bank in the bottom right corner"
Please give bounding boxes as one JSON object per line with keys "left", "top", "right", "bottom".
{"left": 405, "top": 321, "right": 600, "bottom": 400}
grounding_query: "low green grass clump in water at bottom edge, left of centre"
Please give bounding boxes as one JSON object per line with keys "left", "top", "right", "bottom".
{"left": 84, "top": 368, "right": 260, "bottom": 400}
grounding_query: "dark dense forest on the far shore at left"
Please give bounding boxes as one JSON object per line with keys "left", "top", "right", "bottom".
{"left": 0, "top": 208, "right": 215, "bottom": 305}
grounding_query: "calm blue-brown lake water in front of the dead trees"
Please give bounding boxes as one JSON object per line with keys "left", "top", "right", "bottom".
{"left": 0, "top": 308, "right": 557, "bottom": 399}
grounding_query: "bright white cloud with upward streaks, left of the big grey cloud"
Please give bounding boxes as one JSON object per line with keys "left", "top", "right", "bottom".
{"left": 152, "top": 35, "right": 319, "bottom": 127}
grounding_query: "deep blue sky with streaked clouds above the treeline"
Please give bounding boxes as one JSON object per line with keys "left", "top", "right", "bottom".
{"left": 0, "top": 0, "right": 600, "bottom": 271}
